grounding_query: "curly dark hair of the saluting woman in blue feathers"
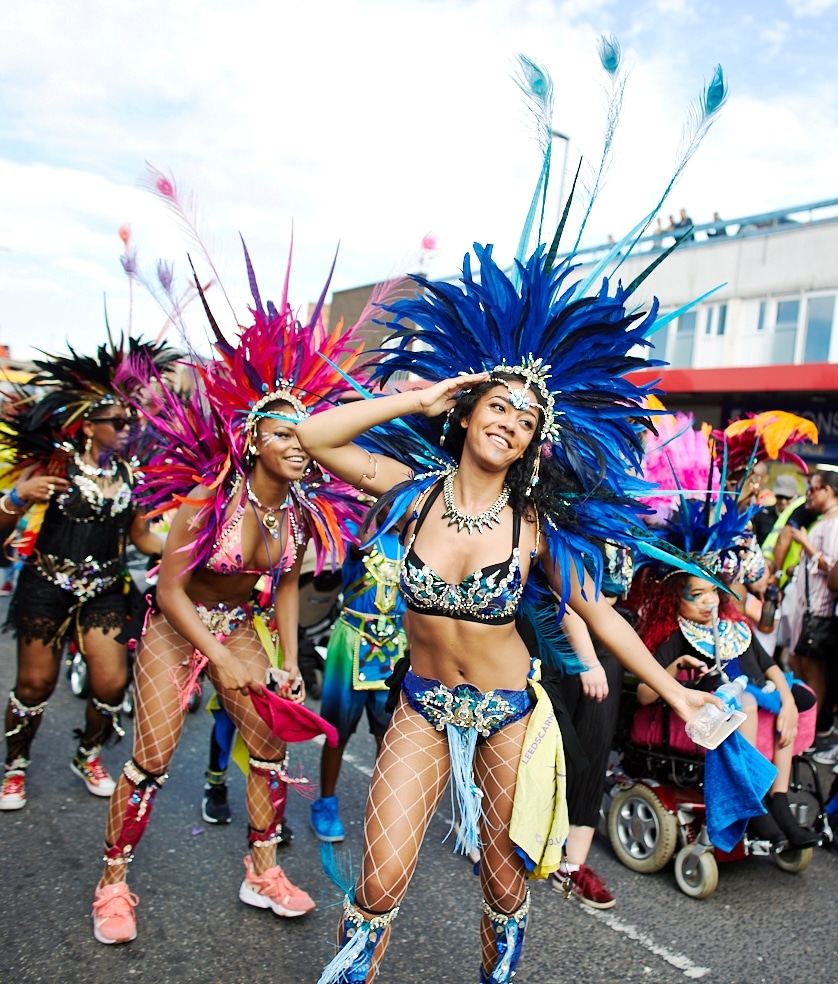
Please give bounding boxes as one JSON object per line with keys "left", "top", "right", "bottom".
{"left": 431, "top": 377, "right": 583, "bottom": 524}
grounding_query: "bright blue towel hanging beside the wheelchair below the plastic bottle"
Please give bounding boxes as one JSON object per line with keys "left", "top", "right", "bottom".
{"left": 704, "top": 731, "right": 777, "bottom": 851}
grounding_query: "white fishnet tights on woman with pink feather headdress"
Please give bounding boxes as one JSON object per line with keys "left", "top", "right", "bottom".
{"left": 102, "top": 612, "right": 285, "bottom": 884}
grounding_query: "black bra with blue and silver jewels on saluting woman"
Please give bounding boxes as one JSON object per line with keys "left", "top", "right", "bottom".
{"left": 399, "top": 485, "right": 524, "bottom": 625}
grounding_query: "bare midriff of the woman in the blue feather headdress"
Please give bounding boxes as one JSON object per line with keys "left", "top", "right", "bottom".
{"left": 408, "top": 611, "right": 530, "bottom": 693}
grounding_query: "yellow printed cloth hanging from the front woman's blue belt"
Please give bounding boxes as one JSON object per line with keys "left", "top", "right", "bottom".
{"left": 509, "top": 680, "right": 570, "bottom": 878}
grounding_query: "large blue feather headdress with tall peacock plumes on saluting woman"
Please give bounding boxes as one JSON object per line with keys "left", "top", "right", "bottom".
{"left": 348, "top": 39, "right": 723, "bottom": 607}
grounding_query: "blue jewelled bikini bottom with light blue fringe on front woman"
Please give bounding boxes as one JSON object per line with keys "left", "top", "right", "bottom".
{"left": 402, "top": 670, "right": 532, "bottom": 854}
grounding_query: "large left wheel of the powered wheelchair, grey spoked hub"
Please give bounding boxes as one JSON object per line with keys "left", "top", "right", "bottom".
{"left": 608, "top": 783, "right": 678, "bottom": 875}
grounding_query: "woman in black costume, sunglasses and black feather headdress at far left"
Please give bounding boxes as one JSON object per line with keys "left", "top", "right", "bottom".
{"left": 0, "top": 339, "right": 172, "bottom": 810}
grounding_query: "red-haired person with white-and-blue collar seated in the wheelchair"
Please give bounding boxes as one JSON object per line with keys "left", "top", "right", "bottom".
{"left": 637, "top": 571, "right": 817, "bottom": 848}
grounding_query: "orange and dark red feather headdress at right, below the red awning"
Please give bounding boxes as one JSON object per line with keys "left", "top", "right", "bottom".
{"left": 713, "top": 410, "right": 818, "bottom": 475}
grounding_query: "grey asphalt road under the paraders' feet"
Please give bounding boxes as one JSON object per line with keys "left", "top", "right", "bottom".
{"left": 0, "top": 600, "right": 838, "bottom": 984}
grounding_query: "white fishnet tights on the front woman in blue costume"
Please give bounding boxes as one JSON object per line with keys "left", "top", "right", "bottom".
{"left": 356, "top": 698, "right": 527, "bottom": 981}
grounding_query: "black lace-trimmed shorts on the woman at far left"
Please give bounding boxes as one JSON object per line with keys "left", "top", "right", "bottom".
{"left": 4, "top": 567, "right": 130, "bottom": 648}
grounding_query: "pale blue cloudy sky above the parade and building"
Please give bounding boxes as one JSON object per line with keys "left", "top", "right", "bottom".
{"left": 0, "top": 0, "right": 838, "bottom": 358}
